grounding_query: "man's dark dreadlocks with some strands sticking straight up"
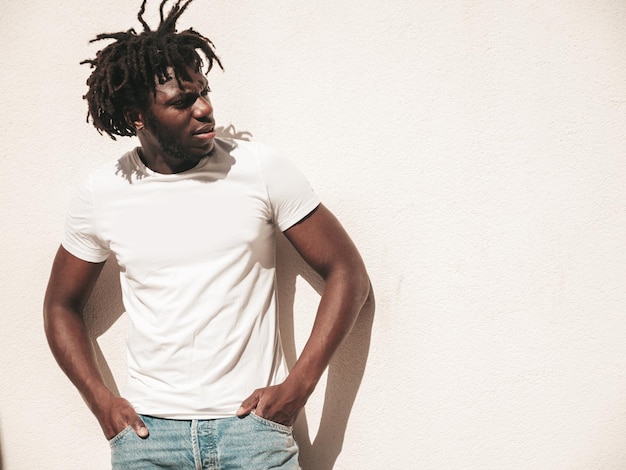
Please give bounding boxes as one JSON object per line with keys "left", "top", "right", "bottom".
{"left": 81, "top": 0, "right": 223, "bottom": 140}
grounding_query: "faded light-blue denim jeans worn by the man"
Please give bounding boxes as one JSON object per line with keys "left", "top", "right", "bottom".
{"left": 109, "top": 414, "right": 300, "bottom": 470}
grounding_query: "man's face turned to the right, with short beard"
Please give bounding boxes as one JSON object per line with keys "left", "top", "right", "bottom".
{"left": 142, "top": 70, "right": 215, "bottom": 164}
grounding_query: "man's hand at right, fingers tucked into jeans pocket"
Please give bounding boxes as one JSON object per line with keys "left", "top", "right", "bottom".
{"left": 237, "top": 379, "right": 310, "bottom": 426}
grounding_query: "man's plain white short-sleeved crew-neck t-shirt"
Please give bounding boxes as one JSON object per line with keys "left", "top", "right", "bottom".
{"left": 62, "top": 140, "right": 319, "bottom": 419}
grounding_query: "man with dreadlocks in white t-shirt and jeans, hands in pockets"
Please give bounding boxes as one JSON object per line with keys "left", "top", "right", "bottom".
{"left": 44, "top": 0, "right": 369, "bottom": 470}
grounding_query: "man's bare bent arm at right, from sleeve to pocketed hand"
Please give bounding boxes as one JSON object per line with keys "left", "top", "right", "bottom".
{"left": 237, "top": 205, "right": 370, "bottom": 425}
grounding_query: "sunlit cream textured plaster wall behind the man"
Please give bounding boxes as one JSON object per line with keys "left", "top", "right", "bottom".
{"left": 0, "top": 0, "right": 626, "bottom": 470}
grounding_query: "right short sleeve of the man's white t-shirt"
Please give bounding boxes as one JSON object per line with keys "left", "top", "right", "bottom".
{"left": 259, "top": 146, "right": 320, "bottom": 232}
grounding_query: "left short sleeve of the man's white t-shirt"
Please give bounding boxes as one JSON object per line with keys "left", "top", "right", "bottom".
{"left": 61, "top": 174, "right": 109, "bottom": 263}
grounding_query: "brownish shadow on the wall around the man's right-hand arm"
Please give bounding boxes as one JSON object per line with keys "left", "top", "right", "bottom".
{"left": 277, "top": 236, "right": 375, "bottom": 470}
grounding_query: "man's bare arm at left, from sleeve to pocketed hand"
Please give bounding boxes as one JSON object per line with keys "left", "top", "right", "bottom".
{"left": 44, "top": 247, "right": 148, "bottom": 439}
